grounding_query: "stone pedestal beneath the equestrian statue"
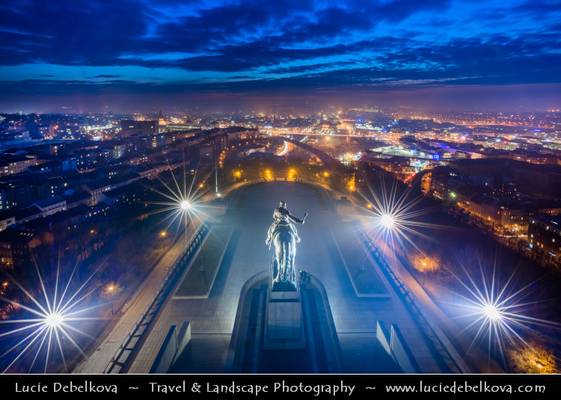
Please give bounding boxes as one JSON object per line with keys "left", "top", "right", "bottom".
{"left": 264, "top": 289, "right": 306, "bottom": 350}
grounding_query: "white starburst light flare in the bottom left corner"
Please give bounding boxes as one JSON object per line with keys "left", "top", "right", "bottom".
{"left": 0, "top": 263, "right": 103, "bottom": 373}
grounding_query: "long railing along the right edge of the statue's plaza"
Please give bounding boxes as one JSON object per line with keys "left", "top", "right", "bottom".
{"left": 360, "top": 231, "right": 462, "bottom": 372}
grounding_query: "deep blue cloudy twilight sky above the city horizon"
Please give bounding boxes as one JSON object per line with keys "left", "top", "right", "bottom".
{"left": 0, "top": 0, "right": 561, "bottom": 112}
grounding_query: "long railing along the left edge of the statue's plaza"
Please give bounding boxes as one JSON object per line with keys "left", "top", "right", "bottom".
{"left": 103, "top": 223, "right": 209, "bottom": 374}
